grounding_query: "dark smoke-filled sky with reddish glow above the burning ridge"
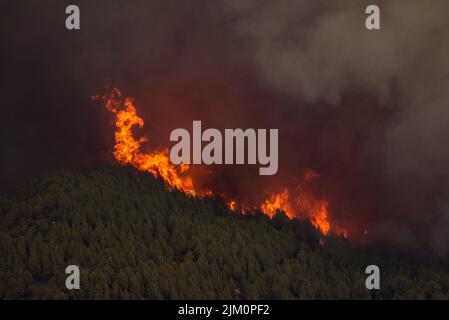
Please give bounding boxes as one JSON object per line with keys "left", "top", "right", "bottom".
{"left": 0, "top": 0, "right": 449, "bottom": 254}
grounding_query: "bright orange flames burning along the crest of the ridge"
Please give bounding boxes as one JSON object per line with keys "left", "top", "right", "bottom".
{"left": 94, "top": 88, "right": 348, "bottom": 238}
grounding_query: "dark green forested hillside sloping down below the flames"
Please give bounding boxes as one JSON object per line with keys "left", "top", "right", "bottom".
{"left": 0, "top": 165, "right": 449, "bottom": 299}
